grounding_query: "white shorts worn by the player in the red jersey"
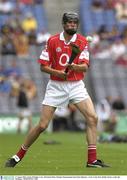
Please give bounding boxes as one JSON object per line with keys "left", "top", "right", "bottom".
{"left": 42, "top": 80, "right": 89, "bottom": 107}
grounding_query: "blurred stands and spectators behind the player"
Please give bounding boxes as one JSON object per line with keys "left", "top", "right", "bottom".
{"left": 0, "top": 0, "right": 127, "bottom": 141}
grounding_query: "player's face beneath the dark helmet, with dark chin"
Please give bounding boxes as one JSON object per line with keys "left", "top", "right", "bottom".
{"left": 63, "top": 20, "right": 78, "bottom": 36}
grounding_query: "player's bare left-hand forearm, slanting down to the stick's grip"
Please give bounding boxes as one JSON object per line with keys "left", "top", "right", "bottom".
{"left": 40, "top": 64, "right": 67, "bottom": 80}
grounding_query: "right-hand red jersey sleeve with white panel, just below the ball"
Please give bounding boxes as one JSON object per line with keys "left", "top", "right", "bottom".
{"left": 79, "top": 43, "right": 89, "bottom": 66}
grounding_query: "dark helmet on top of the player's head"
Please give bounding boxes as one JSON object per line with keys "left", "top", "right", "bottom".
{"left": 62, "top": 12, "right": 79, "bottom": 24}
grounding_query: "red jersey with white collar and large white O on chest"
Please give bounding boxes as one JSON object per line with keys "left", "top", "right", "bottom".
{"left": 38, "top": 32, "right": 89, "bottom": 81}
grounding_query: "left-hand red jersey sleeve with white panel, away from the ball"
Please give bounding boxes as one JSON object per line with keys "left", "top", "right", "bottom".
{"left": 38, "top": 40, "right": 50, "bottom": 65}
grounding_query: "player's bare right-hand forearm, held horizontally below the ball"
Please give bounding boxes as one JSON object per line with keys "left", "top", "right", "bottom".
{"left": 67, "top": 63, "right": 88, "bottom": 72}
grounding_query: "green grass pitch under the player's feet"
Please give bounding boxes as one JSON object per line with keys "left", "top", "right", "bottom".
{"left": 0, "top": 132, "right": 127, "bottom": 175}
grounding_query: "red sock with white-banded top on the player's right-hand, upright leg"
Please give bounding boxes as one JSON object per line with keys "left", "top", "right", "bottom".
{"left": 88, "top": 144, "right": 97, "bottom": 163}
